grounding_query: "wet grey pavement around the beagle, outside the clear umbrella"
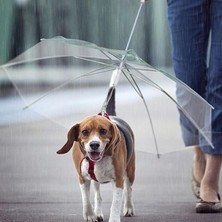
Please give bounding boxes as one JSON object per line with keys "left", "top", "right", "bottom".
{"left": 0, "top": 96, "right": 222, "bottom": 222}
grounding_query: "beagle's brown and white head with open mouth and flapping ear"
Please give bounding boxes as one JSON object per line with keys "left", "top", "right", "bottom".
{"left": 57, "top": 115, "right": 120, "bottom": 161}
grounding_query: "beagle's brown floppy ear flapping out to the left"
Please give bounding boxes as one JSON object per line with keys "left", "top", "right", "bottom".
{"left": 57, "top": 124, "right": 79, "bottom": 154}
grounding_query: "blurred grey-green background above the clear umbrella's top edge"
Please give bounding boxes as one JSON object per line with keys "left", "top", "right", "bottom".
{"left": 0, "top": 0, "right": 171, "bottom": 67}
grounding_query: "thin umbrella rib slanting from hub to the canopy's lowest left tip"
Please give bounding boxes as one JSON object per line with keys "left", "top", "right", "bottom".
{"left": 23, "top": 67, "right": 112, "bottom": 110}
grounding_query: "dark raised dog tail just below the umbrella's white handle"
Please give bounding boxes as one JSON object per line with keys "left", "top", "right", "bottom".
{"left": 106, "top": 86, "right": 116, "bottom": 116}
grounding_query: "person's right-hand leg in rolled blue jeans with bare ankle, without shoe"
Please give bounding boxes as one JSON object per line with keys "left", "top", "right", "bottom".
{"left": 197, "top": 0, "right": 222, "bottom": 206}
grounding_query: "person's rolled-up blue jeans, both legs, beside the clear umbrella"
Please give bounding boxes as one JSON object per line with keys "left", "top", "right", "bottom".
{"left": 167, "top": 0, "right": 222, "bottom": 154}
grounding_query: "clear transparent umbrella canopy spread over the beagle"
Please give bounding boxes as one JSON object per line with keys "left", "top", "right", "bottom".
{"left": 1, "top": 37, "right": 213, "bottom": 154}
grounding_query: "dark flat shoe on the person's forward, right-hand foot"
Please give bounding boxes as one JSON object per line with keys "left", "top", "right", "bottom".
{"left": 196, "top": 194, "right": 222, "bottom": 213}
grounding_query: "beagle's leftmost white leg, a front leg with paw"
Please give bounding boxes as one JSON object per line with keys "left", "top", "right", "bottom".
{"left": 80, "top": 180, "right": 98, "bottom": 222}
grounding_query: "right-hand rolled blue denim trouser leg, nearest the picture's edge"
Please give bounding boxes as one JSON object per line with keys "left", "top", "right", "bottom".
{"left": 202, "top": 0, "right": 222, "bottom": 155}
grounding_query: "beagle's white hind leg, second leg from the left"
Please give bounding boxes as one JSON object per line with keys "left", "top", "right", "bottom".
{"left": 92, "top": 181, "right": 104, "bottom": 222}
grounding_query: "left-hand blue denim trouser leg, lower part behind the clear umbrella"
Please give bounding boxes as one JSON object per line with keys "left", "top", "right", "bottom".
{"left": 168, "top": 0, "right": 210, "bottom": 146}
